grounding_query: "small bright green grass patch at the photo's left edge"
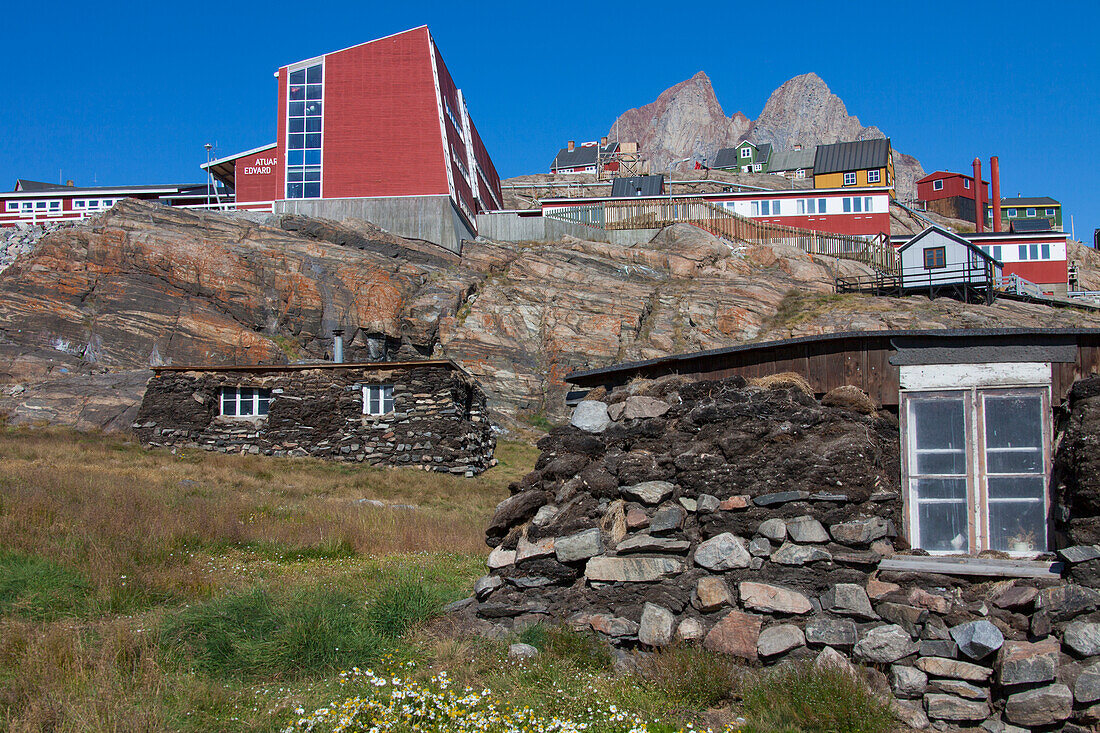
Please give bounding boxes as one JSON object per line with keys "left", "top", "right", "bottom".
{"left": 0, "top": 550, "right": 91, "bottom": 621}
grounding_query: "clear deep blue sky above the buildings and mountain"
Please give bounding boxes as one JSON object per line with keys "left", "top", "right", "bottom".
{"left": 0, "top": 0, "right": 1100, "bottom": 242}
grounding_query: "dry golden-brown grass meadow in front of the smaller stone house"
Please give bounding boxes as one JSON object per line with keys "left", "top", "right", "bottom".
{"left": 0, "top": 428, "right": 537, "bottom": 732}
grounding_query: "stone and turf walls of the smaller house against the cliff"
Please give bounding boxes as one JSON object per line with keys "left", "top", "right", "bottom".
{"left": 133, "top": 364, "right": 495, "bottom": 475}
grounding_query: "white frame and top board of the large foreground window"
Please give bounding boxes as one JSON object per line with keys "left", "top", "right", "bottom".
{"left": 899, "top": 362, "right": 1053, "bottom": 557}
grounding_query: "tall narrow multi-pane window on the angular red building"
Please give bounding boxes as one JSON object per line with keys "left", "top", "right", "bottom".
{"left": 286, "top": 64, "right": 325, "bottom": 198}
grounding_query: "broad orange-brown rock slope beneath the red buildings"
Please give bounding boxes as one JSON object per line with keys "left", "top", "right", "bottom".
{"left": 0, "top": 201, "right": 1100, "bottom": 429}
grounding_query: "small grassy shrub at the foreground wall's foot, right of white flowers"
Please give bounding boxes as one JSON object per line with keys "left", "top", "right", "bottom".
{"left": 639, "top": 646, "right": 736, "bottom": 708}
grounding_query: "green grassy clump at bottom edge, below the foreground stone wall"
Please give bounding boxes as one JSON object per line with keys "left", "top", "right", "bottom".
{"left": 741, "top": 663, "right": 893, "bottom": 733}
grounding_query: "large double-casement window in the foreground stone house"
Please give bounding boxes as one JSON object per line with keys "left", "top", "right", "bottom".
{"left": 902, "top": 385, "right": 1049, "bottom": 554}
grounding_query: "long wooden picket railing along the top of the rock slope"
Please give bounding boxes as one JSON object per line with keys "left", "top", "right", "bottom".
{"left": 543, "top": 198, "right": 898, "bottom": 273}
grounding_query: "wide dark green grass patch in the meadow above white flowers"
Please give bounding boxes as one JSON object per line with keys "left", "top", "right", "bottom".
{"left": 161, "top": 588, "right": 389, "bottom": 676}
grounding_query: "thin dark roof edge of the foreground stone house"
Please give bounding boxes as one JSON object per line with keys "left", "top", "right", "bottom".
{"left": 565, "top": 328, "right": 1100, "bottom": 384}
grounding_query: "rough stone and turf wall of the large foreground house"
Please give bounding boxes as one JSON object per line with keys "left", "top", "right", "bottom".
{"left": 471, "top": 378, "right": 1100, "bottom": 731}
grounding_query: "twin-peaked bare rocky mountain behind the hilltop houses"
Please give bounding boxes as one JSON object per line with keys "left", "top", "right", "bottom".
{"left": 612, "top": 72, "right": 924, "bottom": 199}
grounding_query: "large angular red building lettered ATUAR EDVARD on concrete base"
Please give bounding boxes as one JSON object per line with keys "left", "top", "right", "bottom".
{"left": 204, "top": 25, "right": 503, "bottom": 250}
